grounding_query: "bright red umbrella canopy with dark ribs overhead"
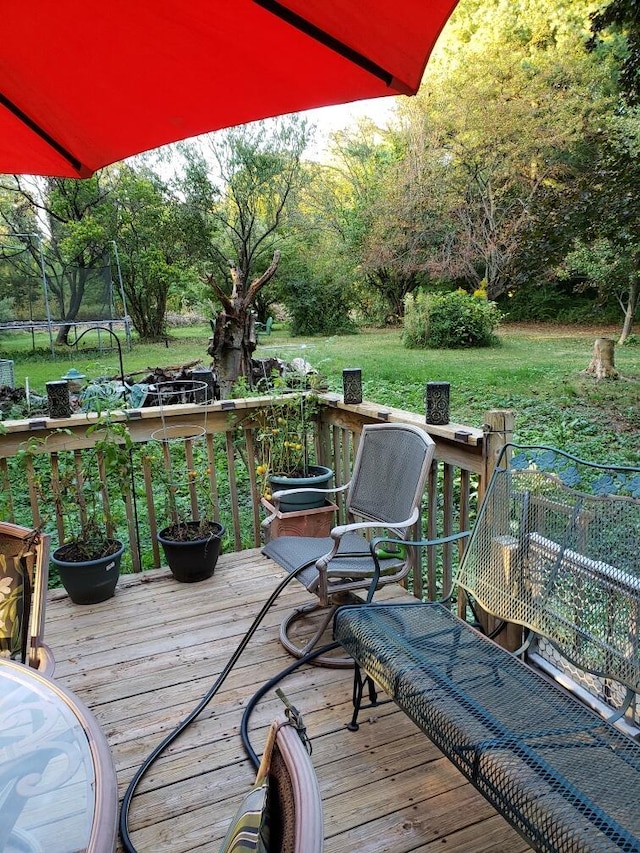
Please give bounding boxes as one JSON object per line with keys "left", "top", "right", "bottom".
{"left": 0, "top": 0, "right": 457, "bottom": 177}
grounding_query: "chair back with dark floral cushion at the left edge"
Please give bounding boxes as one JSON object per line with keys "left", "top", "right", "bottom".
{"left": 0, "top": 522, "right": 49, "bottom": 668}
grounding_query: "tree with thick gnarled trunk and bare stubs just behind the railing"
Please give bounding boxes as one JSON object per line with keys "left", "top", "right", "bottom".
{"left": 183, "top": 116, "right": 309, "bottom": 396}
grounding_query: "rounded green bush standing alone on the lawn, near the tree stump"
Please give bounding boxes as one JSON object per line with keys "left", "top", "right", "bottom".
{"left": 402, "top": 290, "right": 502, "bottom": 349}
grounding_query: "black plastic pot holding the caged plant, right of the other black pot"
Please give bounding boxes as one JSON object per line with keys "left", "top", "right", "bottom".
{"left": 158, "top": 521, "right": 224, "bottom": 583}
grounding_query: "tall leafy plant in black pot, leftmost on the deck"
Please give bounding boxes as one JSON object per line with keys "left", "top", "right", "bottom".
{"left": 43, "top": 414, "right": 133, "bottom": 604}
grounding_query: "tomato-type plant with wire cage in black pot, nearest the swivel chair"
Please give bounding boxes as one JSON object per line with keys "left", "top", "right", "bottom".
{"left": 147, "top": 430, "right": 225, "bottom": 583}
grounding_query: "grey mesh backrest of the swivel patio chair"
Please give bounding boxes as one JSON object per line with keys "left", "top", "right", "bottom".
{"left": 347, "top": 423, "right": 435, "bottom": 538}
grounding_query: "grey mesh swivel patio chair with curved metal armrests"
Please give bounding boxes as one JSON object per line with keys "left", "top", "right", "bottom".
{"left": 263, "top": 423, "right": 435, "bottom": 666}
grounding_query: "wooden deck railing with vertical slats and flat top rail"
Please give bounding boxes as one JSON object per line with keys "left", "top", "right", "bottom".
{"left": 0, "top": 394, "right": 513, "bottom": 598}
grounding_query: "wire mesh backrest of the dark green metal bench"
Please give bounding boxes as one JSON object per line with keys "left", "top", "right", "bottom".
{"left": 457, "top": 445, "right": 640, "bottom": 692}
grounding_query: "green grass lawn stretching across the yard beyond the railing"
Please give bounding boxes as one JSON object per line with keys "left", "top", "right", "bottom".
{"left": 0, "top": 325, "right": 640, "bottom": 465}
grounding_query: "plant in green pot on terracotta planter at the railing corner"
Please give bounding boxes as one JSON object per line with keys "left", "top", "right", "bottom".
{"left": 251, "top": 392, "right": 333, "bottom": 512}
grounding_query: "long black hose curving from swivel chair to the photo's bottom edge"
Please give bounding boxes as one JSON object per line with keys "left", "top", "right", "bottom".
{"left": 119, "top": 563, "right": 316, "bottom": 853}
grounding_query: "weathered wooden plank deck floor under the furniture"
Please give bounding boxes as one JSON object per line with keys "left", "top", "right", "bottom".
{"left": 46, "top": 550, "right": 530, "bottom": 853}
